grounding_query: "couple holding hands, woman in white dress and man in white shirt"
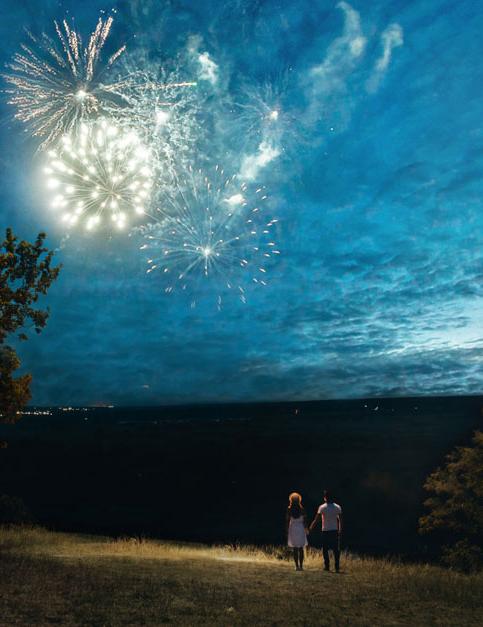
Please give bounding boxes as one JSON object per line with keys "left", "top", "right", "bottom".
{"left": 287, "top": 490, "right": 342, "bottom": 573}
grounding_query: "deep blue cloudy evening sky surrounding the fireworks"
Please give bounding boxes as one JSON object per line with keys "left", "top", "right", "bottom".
{"left": 0, "top": 0, "right": 483, "bottom": 405}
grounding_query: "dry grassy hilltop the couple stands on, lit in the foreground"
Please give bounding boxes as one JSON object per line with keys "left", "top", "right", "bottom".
{"left": 0, "top": 528, "right": 483, "bottom": 627}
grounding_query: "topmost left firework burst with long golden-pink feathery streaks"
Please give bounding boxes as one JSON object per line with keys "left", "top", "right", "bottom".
{"left": 4, "top": 17, "right": 126, "bottom": 148}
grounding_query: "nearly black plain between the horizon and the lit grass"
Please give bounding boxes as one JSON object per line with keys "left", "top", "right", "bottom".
{"left": 0, "top": 396, "right": 483, "bottom": 558}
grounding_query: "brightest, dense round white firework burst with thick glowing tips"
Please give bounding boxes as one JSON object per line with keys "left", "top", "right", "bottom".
{"left": 45, "top": 120, "right": 152, "bottom": 230}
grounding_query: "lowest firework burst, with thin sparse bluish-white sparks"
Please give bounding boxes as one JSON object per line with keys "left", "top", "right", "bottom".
{"left": 142, "top": 167, "right": 280, "bottom": 304}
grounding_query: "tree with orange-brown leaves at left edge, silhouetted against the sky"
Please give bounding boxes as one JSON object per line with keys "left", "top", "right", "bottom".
{"left": 0, "top": 229, "right": 60, "bottom": 436}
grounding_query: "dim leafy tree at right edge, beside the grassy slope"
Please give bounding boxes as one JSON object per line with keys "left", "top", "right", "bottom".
{"left": 419, "top": 431, "right": 483, "bottom": 570}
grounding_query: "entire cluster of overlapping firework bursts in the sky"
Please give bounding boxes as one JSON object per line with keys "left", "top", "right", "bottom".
{"left": 4, "top": 9, "right": 288, "bottom": 305}
